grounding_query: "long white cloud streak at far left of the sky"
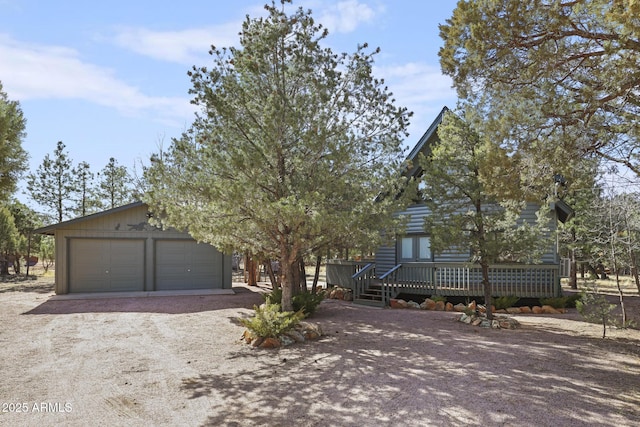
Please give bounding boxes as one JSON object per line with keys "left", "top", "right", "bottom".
{"left": 0, "top": 34, "right": 194, "bottom": 122}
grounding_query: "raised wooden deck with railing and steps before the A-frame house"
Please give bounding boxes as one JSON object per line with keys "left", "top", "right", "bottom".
{"left": 327, "top": 261, "right": 561, "bottom": 305}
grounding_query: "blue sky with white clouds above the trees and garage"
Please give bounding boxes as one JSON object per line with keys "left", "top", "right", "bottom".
{"left": 0, "top": 0, "right": 457, "bottom": 206}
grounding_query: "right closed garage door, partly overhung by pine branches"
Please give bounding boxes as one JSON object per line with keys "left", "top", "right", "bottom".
{"left": 156, "top": 240, "right": 222, "bottom": 291}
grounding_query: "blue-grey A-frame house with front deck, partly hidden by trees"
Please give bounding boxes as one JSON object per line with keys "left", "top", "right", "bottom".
{"left": 327, "top": 107, "right": 573, "bottom": 306}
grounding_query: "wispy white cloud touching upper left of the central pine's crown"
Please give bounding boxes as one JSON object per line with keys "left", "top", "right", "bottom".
{"left": 113, "top": 23, "right": 241, "bottom": 65}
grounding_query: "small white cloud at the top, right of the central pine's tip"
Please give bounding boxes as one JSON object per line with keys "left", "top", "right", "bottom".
{"left": 318, "top": 0, "right": 384, "bottom": 33}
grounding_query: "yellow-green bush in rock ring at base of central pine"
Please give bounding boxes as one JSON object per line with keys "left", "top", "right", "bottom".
{"left": 239, "top": 303, "right": 304, "bottom": 338}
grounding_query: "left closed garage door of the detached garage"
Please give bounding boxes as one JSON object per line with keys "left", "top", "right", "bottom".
{"left": 69, "top": 239, "right": 144, "bottom": 292}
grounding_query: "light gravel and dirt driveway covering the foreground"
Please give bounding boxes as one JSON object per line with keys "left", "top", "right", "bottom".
{"left": 0, "top": 282, "right": 640, "bottom": 427}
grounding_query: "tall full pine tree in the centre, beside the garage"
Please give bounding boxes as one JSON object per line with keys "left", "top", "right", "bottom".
{"left": 144, "top": 1, "right": 409, "bottom": 311}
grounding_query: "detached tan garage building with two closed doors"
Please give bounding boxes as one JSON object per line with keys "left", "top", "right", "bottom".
{"left": 34, "top": 202, "right": 231, "bottom": 294}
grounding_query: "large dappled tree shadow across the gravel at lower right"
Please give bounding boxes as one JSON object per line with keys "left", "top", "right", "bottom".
{"left": 182, "top": 304, "right": 640, "bottom": 426}
